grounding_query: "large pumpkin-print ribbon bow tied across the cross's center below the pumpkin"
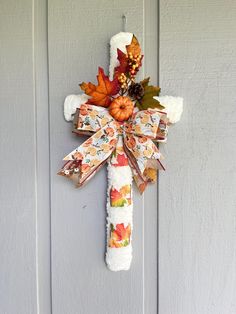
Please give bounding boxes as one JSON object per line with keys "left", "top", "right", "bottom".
{"left": 58, "top": 104, "right": 168, "bottom": 192}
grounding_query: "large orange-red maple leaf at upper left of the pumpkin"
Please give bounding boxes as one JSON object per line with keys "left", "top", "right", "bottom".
{"left": 80, "top": 67, "right": 120, "bottom": 107}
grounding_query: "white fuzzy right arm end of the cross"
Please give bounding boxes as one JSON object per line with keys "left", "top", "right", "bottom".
{"left": 153, "top": 96, "right": 183, "bottom": 123}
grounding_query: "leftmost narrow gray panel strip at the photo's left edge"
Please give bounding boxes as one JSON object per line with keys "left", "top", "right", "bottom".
{"left": 0, "top": 0, "right": 37, "bottom": 314}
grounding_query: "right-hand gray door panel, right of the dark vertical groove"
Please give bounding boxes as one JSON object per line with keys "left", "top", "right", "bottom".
{"left": 159, "top": 0, "right": 236, "bottom": 314}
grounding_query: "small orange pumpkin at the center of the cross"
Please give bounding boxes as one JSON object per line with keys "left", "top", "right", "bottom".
{"left": 109, "top": 96, "right": 134, "bottom": 122}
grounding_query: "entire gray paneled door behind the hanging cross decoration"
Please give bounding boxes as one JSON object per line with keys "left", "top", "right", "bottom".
{"left": 0, "top": 0, "right": 236, "bottom": 314}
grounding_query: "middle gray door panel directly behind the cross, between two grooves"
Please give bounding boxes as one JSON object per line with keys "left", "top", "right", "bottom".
{"left": 48, "top": 0, "right": 157, "bottom": 314}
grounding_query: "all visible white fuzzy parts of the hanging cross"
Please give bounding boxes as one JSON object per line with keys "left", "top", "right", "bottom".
{"left": 61, "top": 33, "right": 183, "bottom": 271}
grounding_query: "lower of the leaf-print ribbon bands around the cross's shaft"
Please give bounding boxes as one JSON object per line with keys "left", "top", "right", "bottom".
{"left": 108, "top": 223, "right": 131, "bottom": 248}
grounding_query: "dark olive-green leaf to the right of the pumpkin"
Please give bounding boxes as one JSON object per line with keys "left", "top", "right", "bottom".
{"left": 136, "top": 77, "right": 164, "bottom": 110}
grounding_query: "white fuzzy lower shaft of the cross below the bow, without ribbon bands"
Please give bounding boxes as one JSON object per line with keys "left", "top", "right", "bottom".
{"left": 106, "top": 163, "right": 133, "bottom": 271}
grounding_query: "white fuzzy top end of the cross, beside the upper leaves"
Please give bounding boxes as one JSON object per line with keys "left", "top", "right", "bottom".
{"left": 109, "top": 32, "right": 133, "bottom": 80}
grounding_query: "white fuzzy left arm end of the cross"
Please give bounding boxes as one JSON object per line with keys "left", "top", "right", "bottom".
{"left": 64, "top": 94, "right": 90, "bottom": 121}
